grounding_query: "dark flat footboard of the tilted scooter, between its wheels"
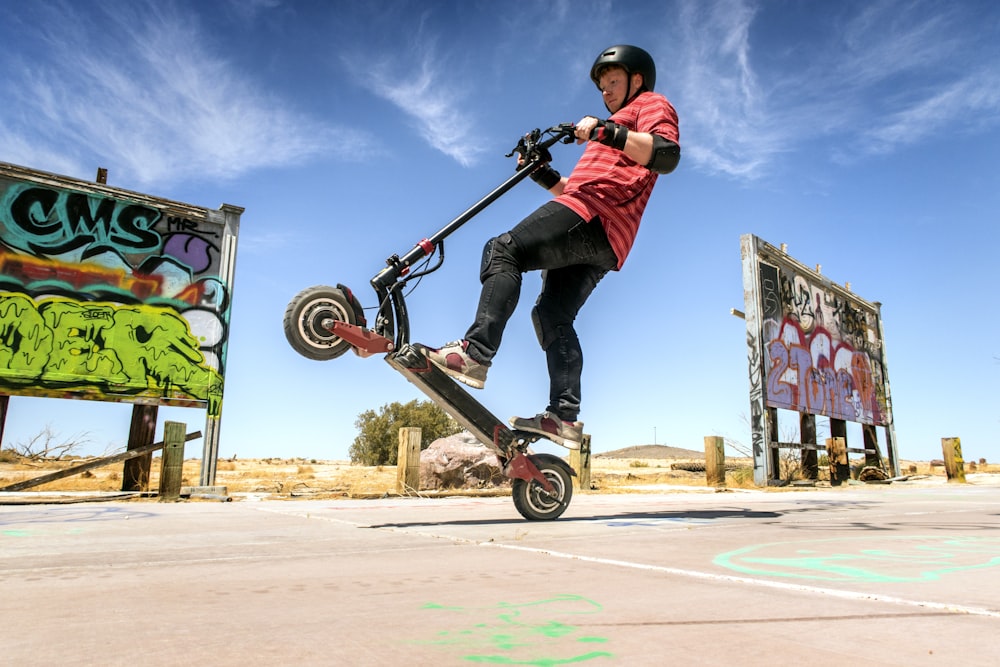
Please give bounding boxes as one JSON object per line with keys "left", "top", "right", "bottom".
{"left": 385, "top": 345, "right": 516, "bottom": 462}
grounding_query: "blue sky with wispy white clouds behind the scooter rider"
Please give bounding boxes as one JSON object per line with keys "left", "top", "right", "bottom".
{"left": 0, "top": 0, "right": 1000, "bottom": 470}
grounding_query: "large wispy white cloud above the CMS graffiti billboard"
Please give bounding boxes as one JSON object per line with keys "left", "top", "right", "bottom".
{"left": 0, "top": 3, "right": 366, "bottom": 186}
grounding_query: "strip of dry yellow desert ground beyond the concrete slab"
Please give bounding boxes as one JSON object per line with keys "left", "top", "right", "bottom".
{"left": 0, "top": 445, "right": 1000, "bottom": 499}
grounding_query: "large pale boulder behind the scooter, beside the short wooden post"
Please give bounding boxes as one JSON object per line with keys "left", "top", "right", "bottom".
{"left": 420, "top": 431, "right": 510, "bottom": 489}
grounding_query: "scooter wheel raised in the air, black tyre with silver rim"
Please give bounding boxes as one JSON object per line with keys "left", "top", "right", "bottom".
{"left": 284, "top": 285, "right": 361, "bottom": 361}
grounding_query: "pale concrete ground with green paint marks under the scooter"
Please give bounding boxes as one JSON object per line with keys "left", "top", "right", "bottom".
{"left": 0, "top": 482, "right": 1000, "bottom": 667}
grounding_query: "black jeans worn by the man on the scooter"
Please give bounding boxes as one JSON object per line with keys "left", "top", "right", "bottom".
{"left": 465, "top": 202, "right": 618, "bottom": 421}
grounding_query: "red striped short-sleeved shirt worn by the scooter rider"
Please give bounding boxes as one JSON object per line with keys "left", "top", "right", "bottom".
{"left": 556, "top": 92, "right": 680, "bottom": 269}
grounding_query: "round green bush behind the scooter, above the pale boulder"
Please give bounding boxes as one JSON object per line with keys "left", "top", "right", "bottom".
{"left": 350, "top": 400, "right": 462, "bottom": 466}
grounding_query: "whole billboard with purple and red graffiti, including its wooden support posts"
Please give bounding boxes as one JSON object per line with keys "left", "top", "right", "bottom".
{"left": 740, "top": 234, "right": 899, "bottom": 485}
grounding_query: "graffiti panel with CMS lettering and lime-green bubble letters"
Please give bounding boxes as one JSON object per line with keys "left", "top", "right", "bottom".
{"left": 0, "top": 163, "right": 242, "bottom": 416}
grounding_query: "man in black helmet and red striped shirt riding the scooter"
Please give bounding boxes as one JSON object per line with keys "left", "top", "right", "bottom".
{"left": 423, "top": 45, "right": 680, "bottom": 449}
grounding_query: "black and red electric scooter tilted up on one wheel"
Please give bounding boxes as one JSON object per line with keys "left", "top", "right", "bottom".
{"left": 284, "top": 123, "right": 576, "bottom": 521}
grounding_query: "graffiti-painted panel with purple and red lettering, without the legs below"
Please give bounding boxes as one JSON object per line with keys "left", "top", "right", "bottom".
{"left": 744, "top": 239, "right": 890, "bottom": 426}
